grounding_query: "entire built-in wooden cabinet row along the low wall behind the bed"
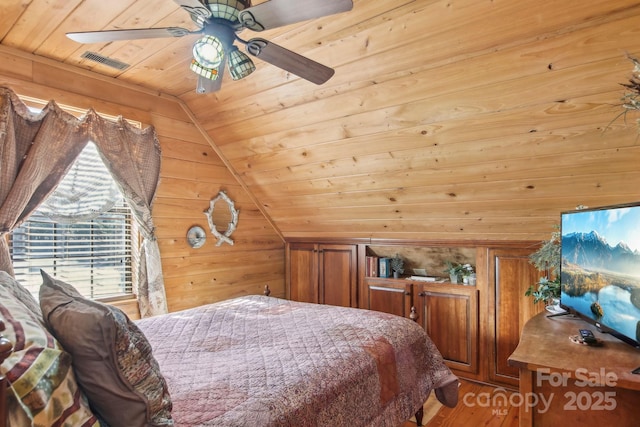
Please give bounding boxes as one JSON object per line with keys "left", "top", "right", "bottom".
{"left": 287, "top": 240, "right": 544, "bottom": 388}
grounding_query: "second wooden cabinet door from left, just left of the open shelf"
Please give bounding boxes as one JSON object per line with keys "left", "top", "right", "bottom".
{"left": 318, "top": 245, "right": 358, "bottom": 307}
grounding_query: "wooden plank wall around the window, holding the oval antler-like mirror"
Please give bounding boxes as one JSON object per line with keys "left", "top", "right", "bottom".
{"left": 0, "top": 46, "right": 284, "bottom": 311}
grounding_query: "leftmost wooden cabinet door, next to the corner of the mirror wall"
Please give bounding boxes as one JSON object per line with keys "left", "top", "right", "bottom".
{"left": 286, "top": 243, "right": 320, "bottom": 303}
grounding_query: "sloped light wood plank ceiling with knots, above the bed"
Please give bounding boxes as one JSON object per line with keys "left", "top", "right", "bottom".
{"left": 0, "top": 0, "right": 640, "bottom": 240}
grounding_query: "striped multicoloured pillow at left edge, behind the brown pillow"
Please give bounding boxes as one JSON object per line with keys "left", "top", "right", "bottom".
{"left": 0, "top": 277, "right": 100, "bottom": 427}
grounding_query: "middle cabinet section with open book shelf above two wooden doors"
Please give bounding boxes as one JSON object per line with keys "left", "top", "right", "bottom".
{"left": 359, "top": 245, "right": 486, "bottom": 379}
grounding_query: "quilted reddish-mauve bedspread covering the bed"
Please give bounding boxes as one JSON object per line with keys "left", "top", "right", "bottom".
{"left": 136, "top": 295, "right": 457, "bottom": 427}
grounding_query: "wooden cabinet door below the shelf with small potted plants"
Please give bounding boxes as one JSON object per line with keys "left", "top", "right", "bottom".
{"left": 415, "top": 284, "right": 478, "bottom": 373}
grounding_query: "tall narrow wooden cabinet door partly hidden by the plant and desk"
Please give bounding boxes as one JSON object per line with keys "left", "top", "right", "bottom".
{"left": 489, "top": 248, "right": 544, "bottom": 385}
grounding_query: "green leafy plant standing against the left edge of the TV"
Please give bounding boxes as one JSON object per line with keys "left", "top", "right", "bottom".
{"left": 525, "top": 231, "right": 560, "bottom": 305}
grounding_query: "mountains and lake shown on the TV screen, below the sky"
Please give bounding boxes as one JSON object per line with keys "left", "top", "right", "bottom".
{"left": 561, "top": 231, "right": 640, "bottom": 341}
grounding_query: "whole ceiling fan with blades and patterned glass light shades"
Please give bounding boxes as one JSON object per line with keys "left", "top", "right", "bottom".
{"left": 67, "top": 0, "right": 353, "bottom": 93}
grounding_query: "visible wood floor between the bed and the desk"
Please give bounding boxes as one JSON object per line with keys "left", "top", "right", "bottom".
{"left": 400, "top": 380, "right": 518, "bottom": 427}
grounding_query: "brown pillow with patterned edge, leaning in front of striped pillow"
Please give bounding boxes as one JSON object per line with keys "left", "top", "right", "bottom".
{"left": 40, "top": 271, "right": 173, "bottom": 427}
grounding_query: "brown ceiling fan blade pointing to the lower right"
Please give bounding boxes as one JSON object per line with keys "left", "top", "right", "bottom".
{"left": 246, "top": 38, "right": 335, "bottom": 85}
